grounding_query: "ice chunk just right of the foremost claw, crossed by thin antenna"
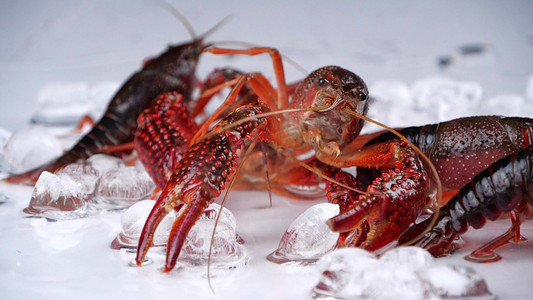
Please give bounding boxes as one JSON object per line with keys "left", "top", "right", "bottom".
{"left": 179, "top": 203, "right": 247, "bottom": 268}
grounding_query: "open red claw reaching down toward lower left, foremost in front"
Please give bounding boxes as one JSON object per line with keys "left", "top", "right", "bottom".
{"left": 136, "top": 106, "right": 265, "bottom": 272}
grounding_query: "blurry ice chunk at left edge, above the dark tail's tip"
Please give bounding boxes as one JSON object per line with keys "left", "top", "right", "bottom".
{"left": 3, "top": 126, "right": 63, "bottom": 173}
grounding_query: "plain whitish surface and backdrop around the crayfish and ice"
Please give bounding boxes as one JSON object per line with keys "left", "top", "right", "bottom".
{"left": 0, "top": 0, "right": 533, "bottom": 299}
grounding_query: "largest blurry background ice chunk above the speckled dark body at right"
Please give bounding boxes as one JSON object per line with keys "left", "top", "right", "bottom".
{"left": 411, "top": 77, "right": 483, "bottom": 121}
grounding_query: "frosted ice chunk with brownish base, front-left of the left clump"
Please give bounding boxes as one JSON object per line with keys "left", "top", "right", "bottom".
{"left": 23, "top": 171, "right": 90, "bottom": 220}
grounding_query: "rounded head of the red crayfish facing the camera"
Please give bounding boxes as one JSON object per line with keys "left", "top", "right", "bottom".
{"left": 293, "top": 66, "right": 368, "bottom": 157}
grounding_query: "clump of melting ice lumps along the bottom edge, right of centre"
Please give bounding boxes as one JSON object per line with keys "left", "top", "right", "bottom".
{"left": 312, "top": 247, "right": 495, "bottom": 299}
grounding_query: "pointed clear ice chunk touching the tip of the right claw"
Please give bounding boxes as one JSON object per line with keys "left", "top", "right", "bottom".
{"left": 268, "top": 203, "right": 339, "bottom": 263}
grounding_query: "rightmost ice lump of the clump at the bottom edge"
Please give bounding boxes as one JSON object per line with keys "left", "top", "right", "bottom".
{"left": 418, "top": 264, "right": 495, "bottom": 299}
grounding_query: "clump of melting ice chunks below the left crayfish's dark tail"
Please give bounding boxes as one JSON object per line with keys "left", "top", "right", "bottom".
{"left": 24, "top": 154, "right": 155, "bottom": 220}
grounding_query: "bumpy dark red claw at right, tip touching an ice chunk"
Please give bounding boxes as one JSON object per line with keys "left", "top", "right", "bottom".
{"left": 328, "top": 144, "right": 427, "bottom": 251}
